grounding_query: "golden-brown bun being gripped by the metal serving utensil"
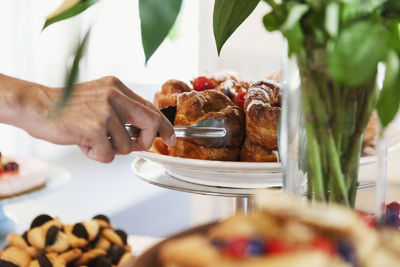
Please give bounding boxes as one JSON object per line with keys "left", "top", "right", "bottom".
{"left": 168, "top": 90, "right": 244, "bottom": 161}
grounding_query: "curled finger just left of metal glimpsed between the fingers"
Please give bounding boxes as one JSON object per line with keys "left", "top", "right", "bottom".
{"left": 107, "top": 110, "right": 132, "bottom": 155}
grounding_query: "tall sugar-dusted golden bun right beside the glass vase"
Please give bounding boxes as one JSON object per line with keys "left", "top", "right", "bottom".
{"left": 242, "top": 80, "right": 281, "bottom": 161}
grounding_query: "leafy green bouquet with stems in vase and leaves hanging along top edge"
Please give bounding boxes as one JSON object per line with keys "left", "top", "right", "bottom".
{"left": 45, "top": 0, "right": 400, "bottom": 206}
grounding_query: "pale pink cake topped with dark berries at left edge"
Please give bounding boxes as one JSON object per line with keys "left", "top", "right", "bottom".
{"left": 0, "top": 153, "right": 47, "bottom": 199}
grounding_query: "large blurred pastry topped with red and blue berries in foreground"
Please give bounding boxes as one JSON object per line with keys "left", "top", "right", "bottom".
{"left": 159, "top": 193, "right": 400, "bottom": 267}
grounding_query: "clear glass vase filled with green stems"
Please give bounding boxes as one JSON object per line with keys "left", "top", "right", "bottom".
{"left": 279, "top": 42, "right": 385, "bottom": 207}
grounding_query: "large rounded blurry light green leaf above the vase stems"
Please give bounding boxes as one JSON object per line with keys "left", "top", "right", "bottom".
{"left": 329, "top": 21, "right": 388, "bottom": 87}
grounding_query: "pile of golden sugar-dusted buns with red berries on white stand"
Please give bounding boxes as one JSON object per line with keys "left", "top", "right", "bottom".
{"left": 151, "top": 71, "right": 377, "bottom": 162}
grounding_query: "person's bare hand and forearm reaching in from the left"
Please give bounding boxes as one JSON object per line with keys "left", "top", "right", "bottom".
{"left": 0, "top": 74, "right": 176, "bottom": 162}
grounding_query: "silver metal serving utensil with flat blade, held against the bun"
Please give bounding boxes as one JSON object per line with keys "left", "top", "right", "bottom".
{"left": 125, "top": 106, "right": 241, "bottom": 147}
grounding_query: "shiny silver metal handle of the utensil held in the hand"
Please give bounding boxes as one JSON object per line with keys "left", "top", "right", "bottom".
{"left": 125, "top": 124, "right": 226, "bottom": 138}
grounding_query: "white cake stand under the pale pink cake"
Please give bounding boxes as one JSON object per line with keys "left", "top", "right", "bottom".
{"left": 0, "top": 165, "right": 71, "bottom": 246}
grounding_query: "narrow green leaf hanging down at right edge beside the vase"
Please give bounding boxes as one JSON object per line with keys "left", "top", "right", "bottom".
{"left": 376, "top": 50, "right": 400, "bottom": 130}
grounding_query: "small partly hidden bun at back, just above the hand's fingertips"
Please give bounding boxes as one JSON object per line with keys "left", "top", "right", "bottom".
{"left": 154, "top": 80, "right": 192, "bottom": 109}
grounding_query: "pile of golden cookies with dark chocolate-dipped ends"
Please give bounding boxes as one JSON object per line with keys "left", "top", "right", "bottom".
{"left": 0, "top": 214, "right": 135, "bottom": 267}
